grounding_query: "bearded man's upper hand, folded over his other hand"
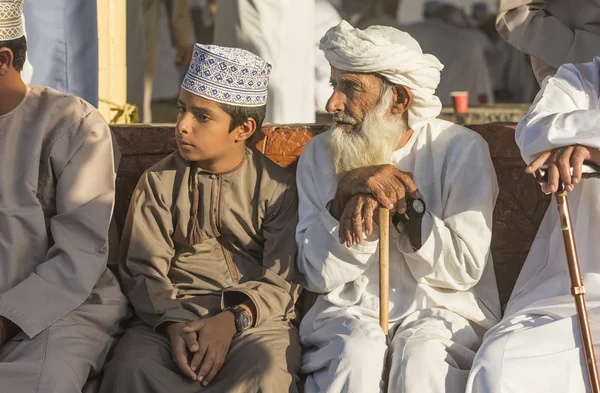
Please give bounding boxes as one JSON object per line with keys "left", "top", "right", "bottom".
{"left": 331, "top": 164, "right": 420, "bottom": 220}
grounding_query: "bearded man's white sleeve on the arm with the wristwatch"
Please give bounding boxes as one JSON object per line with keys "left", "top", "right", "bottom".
{"left": 398, "top": 136, "right": 498, "bottom": 291}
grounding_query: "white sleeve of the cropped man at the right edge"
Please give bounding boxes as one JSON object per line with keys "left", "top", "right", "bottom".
{"left": 515, "top": 59, "right": 600, "bottom": 164}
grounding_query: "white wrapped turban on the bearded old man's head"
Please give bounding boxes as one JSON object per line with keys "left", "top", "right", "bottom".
{"left": 320, "top": 21, "right": 444, "bottom": 130}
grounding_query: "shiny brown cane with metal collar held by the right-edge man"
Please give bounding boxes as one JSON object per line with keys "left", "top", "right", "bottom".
{"left": 538, "top": 162, "right": 600, "bottom": 393}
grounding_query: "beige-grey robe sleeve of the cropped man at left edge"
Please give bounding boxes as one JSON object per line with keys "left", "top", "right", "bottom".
{"left": 0, "top": 111, "right": 116, "bottom": 338}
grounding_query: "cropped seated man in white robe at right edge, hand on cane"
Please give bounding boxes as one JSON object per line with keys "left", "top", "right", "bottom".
{"left": 467, "top": 57, "right": 600, "bottom": 393}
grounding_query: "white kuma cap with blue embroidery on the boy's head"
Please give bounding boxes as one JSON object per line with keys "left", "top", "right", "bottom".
{"left": 181, "top": 44, "right": 271, "bottom": 106}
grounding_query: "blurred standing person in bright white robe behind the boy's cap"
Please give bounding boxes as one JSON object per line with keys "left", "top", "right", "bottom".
{"left": 215, "top": 0, "right": 316, "bottom": 123}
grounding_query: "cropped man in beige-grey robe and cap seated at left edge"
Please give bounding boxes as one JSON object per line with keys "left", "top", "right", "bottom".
{"left": 0, "top": 0, "right": 127, "bottom": 393}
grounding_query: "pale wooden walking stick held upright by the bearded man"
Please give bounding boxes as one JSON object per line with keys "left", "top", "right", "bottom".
{"left": 379, "top": 207, "right": 390, "bottom": 337}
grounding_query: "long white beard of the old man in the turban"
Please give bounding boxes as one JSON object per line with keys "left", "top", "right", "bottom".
{"left": 328, "top": 89, "right": 409, "bottom": 178}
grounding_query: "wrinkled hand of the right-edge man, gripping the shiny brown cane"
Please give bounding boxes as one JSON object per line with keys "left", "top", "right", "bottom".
{"left": 525, "top": 145, "right": 600, "bottom": 193}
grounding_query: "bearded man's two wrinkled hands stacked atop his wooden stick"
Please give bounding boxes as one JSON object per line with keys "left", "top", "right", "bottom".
{"left": 330, "top": 164, "right": 420, "bottom": 247}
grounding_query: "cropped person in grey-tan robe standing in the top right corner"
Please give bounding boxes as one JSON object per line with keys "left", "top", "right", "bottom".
{"left": 496, "top": 0, "right": 600, "bottom": 85}
